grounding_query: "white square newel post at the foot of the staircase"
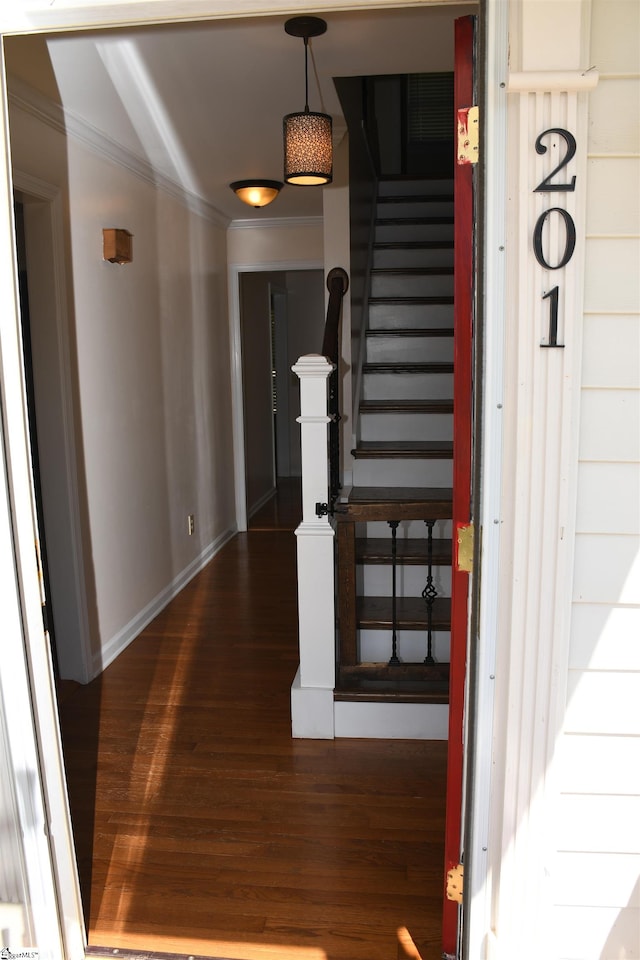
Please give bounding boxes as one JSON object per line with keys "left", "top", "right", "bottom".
{"left": 291, "top": 354, "right": 335, "bottom": 740}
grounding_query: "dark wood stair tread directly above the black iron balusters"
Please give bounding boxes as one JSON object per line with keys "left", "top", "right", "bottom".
{"left": 342, "top": 487, "right": 453, "bottom": 521}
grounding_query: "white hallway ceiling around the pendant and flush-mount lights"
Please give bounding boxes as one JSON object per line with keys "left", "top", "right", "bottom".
{"left": 6, "top": 4, "right": 475, "bottom": 219}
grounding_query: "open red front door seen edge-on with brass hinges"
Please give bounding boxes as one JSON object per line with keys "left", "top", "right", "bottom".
{"left": 442, "top": 17, "right": 478, "bottom": 957}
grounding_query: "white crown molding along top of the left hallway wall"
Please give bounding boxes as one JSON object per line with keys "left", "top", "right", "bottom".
{"left": 8, "top": 77, "right": 229, "bottom": 228}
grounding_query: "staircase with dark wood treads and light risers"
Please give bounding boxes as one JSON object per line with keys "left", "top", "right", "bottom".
{"left": 334, "top": 179, "right": 453, "bottom": 736}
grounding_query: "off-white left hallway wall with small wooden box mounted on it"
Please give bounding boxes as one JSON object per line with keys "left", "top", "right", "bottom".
{"left": 11, "top": 80, "right": 235, "bottom": 679}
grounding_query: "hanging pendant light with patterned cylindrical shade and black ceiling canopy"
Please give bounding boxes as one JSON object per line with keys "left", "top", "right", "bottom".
{"left": 282, "top": 17, "right": 333, "bottom": 186}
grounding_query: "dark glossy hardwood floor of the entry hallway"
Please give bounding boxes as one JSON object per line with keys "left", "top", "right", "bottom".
{"left": 60, "top": 484, "right": 446, "bottom": 960}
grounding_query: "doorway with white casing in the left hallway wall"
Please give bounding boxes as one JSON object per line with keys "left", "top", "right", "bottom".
{"left": 14, "top": 171, "right": 91, "bottom": 683}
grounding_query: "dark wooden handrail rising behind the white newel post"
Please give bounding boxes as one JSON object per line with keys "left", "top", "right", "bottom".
{"left": 322, "top": 267, "right": 349, "bottom": 512}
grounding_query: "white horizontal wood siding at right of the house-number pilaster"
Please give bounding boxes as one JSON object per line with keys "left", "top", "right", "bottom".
{"left": 553, "top": 0, "right": 640, "bottom": 960}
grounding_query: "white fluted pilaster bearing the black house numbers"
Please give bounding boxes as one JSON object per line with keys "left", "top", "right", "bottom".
{"left": 488, "top": 0, "right": 597, "bottom": 960}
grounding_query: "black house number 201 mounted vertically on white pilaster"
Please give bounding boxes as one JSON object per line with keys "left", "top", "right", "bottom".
{"left": 533, "top": 127, "right": 576, "bottom": 347}
